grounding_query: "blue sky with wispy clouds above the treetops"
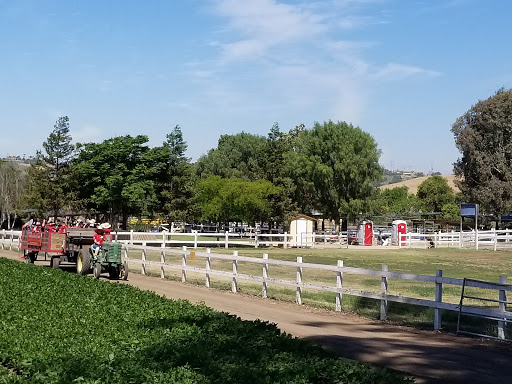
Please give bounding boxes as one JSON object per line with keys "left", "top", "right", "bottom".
{"left": 0, "top": 0, "right": 512, "bottom": 173}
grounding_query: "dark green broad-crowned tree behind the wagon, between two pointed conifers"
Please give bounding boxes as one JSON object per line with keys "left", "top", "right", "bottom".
{"left": 73, "top": 135, "right": 157, "bottom": 228}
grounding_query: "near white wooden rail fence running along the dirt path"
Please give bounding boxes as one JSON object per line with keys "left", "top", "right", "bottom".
{"left": 124, "top": 244, "right": 512, "bottom": 338}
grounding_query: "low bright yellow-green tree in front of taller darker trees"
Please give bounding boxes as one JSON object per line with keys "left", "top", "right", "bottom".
{"left": 196, "top": 176, "right": 280, "bottom": 223}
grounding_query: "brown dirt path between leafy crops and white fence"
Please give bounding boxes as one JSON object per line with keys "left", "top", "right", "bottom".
{"left": 0, "top": 251, "right": 512, "bottom": 384}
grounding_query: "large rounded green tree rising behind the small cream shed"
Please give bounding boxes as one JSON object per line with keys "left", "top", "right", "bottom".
{"left": 289, "top": 121, "right": 382, "bottom": 222}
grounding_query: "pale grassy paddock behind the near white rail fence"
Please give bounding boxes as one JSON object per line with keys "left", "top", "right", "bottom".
{"left": 130, "top": 247, "right": 512, "bottom": 330}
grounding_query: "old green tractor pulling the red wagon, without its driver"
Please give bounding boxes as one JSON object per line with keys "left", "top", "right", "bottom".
{"left": 76, "top": 242, "right": 128, "bottom": 280}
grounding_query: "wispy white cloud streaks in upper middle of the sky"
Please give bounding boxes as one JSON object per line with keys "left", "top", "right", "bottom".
{"left": 188, "top": 0, "right": 440, "bottom": 124}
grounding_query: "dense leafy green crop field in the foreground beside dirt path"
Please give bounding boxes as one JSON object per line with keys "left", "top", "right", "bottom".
{"left": 0, "top": 259, "right": 410, "bottom": 384}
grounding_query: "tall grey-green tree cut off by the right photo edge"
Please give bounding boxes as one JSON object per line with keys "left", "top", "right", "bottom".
{"left": 451, "top": 88, "right": 512, "bottom": 220}
